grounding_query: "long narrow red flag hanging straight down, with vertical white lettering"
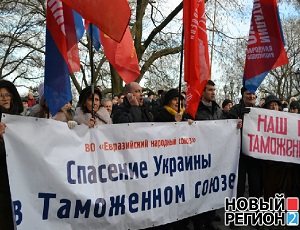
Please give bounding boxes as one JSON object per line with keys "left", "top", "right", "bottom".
{"left": 183, "top": 0, "right": 210, "bottom": 117}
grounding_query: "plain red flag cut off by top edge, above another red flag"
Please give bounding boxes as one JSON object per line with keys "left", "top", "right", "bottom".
{"left": 62, "top": 0, "right": 131, "bottom": 42}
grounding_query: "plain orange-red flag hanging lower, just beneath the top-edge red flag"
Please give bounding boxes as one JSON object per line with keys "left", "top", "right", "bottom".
{"left": 100, "top": 28, "right": 140, "bottom": 84}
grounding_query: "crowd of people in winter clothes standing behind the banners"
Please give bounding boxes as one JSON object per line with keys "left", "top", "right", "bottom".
{"left": 0, "top": 80, "right": 300, "bottom": 230}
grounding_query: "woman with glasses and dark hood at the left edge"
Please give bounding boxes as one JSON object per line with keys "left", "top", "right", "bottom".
{"left": 0, "top": 80, "right": 23, "bottom": 230}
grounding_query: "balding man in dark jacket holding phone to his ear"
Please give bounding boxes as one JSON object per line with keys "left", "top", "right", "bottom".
{"left": 112, "top": 82, "right": 153, "bottom": 124}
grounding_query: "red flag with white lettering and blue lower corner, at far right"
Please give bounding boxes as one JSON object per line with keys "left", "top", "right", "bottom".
{"left": 243, "top": 0, "right": 289, "bottom": 93}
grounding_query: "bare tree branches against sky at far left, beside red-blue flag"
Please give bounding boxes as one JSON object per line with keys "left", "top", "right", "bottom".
{"left": 0, "top": 1, "right": 45, "bottom": 89}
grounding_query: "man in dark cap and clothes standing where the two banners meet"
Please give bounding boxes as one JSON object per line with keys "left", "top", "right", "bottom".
{"left": 228, "top": 86, "right": 262, "bottom": 198}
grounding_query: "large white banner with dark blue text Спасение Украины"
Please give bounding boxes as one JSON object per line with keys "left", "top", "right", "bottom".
{"left": 3, "top": 115, "right": 240, "bottom": 230}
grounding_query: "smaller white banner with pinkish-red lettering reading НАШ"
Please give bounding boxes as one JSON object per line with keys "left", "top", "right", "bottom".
{"left": 242, "top": 108, "right": 300, "bottom": 164}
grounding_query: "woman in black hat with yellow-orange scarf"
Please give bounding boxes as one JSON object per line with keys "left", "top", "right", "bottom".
{"left": 155, "top": 89, "right": 183, "bottom": 122}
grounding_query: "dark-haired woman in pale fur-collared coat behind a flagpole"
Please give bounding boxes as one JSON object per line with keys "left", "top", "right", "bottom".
{"left": 73, "top": 86, "right": 112, "bottom": 128}
